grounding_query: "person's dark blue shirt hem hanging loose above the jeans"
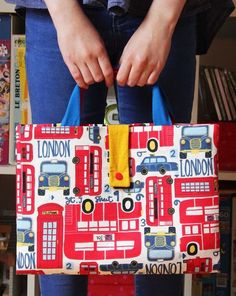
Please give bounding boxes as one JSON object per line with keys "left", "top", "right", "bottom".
{"left": 5, "top": 0, "right": 234, "bottom": 54}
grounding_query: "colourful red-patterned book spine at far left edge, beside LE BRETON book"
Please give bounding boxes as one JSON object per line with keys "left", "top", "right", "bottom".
{"left": 0, "top": 14, "right": 11, "bottom": 164}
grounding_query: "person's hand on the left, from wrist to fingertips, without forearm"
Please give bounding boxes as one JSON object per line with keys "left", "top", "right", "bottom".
{"left": 57, "top": 18, "right": 113, "bottom": 88}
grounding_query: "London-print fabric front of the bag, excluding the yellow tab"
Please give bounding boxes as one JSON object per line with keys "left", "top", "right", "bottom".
{"left": 16, "top": 124, "right": 220, "bottom": 274}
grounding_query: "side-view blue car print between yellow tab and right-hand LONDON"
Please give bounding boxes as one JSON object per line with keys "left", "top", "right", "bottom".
{"left": 136, "top": 156, "right": 178, "bottom": 175}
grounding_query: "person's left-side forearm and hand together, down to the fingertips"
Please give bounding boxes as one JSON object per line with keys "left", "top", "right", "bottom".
{"left": 46, "top": 0, "right": 113, "bottom": 88}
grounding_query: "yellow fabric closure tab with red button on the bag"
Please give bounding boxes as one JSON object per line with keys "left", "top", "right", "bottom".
{"left": 108, "top": 124, "right": 130, "bottom": 187}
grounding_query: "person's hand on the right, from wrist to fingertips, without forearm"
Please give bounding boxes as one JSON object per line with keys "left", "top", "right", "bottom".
{"left": 116, "top": 18, "right": 172, "bottom": 86}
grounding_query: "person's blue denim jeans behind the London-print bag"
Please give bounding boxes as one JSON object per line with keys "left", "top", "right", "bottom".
{"left": 26, "top": 7, "right": 196, "bottom": 296}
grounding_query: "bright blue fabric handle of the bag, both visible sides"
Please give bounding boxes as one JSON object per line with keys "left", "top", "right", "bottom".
{"left": 61, "top": 84, "right": 172, "bottom": 126}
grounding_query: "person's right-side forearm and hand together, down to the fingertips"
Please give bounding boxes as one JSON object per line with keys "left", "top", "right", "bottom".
{"left": 116, "top": 0, "right": 185, "bottom": 87}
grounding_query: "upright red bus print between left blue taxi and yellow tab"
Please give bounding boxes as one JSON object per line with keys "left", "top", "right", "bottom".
{"left": 72, "top": 145, "right": 102, "bottom": 196}
